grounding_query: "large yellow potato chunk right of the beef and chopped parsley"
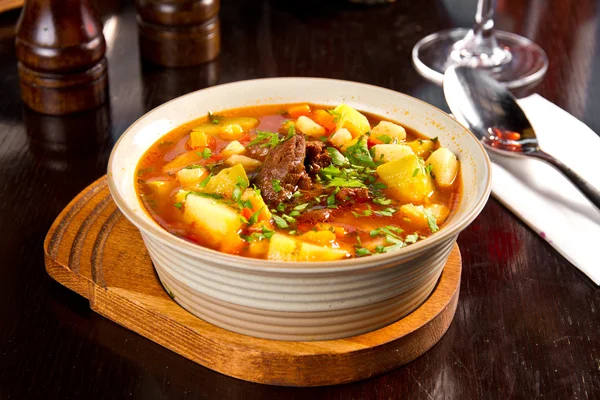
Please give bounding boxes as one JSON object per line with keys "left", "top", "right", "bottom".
{"left": 377, "top": 155, "right": 434, "bottom": 203}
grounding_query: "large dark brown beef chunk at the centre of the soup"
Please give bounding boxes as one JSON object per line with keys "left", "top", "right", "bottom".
{"left": 256, "top": 135, "right": 310, "bottom": 208}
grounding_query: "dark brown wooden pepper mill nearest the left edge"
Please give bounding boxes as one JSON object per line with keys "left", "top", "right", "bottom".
{"left": 15, "top": 0, "right": 108, "bottom": 115}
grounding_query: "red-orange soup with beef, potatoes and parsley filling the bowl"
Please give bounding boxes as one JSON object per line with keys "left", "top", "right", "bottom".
{"left": 136, "top": 104, "right": 461, "bottom": 261}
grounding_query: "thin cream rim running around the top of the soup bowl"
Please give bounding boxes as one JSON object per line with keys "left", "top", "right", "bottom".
{"left": 107, "top": 77, "right": 492, "bottom": 274}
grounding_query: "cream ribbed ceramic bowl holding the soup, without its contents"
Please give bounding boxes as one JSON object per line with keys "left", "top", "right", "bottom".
{"left": 108, "top": 78, "right": 490, "bottom": 341}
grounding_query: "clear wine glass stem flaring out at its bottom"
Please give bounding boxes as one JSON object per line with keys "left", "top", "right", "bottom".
{"left": 451, "top": 0, "right": 511, "bottom": 68}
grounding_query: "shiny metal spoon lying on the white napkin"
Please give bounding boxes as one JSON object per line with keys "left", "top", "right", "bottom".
{"left": 444, "top": 66, "right": 600, "bottom": 210}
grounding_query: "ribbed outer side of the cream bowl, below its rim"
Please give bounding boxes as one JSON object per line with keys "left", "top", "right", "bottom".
{"left": 143, "top": 235, "right": 456, "bottom": 341}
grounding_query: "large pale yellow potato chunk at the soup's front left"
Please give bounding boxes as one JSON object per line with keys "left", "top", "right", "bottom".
{"left": 183, "top": 193, "right": 242, "bottom": 247}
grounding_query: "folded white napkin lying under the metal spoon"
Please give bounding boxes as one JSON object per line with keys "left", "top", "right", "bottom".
{"left": 488, "top": 94, "right": 600, "bottom": 285}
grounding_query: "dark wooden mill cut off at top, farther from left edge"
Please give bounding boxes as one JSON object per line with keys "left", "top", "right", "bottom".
{"left": 136, "top": 0, "right": 221, "bottom": 67}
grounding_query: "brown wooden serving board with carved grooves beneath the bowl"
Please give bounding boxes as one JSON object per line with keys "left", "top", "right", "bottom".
{"left": 44, "top": 177, "right": 461, "bottom": 386}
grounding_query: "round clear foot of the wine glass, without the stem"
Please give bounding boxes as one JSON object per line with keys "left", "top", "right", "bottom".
{"left": 412, "top": 28, "right": 548, "bottom": 89}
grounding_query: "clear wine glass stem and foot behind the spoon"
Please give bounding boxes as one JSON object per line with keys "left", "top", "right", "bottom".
{"left": 412, "top": 0, "right": 548, "bottom": 89}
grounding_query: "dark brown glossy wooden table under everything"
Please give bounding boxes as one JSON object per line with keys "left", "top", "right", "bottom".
{"left": 0, "top": 0, "right": 600, "bottom": 399}
